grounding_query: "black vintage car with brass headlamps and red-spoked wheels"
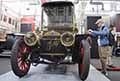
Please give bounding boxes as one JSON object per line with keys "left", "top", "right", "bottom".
{"left": 11, "top": 1, "right": 90, "bottom": 81}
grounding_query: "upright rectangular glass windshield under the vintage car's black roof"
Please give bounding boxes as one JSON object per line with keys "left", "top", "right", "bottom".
{"left": 43, "top": 5, "right": 73, "bottom": 27}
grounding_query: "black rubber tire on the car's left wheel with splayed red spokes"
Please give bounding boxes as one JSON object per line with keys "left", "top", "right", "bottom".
{"left": 11, "top": 39, "right": 31, "bottom": 78}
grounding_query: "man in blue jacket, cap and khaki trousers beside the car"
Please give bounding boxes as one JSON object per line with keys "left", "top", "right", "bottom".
{"left": 88, "top": 19, "right": 110, "bottom": 75}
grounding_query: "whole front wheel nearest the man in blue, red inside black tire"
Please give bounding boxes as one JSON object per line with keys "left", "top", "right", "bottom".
{"left": 78, "top": 40, "right": 90, "bottom": 81}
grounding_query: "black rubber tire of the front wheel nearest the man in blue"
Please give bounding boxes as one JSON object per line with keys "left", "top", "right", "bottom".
{"left": 78, "top": 40, "right": 90, "bottom": 81}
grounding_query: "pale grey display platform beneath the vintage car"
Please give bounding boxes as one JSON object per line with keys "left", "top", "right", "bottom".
{"left": 0, "top": 64, "right": 110, "bottom": 81}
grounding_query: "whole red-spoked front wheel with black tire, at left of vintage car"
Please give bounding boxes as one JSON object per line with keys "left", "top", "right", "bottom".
{"left": 11, "top": 39, "right": 31, "bottom": 77}
